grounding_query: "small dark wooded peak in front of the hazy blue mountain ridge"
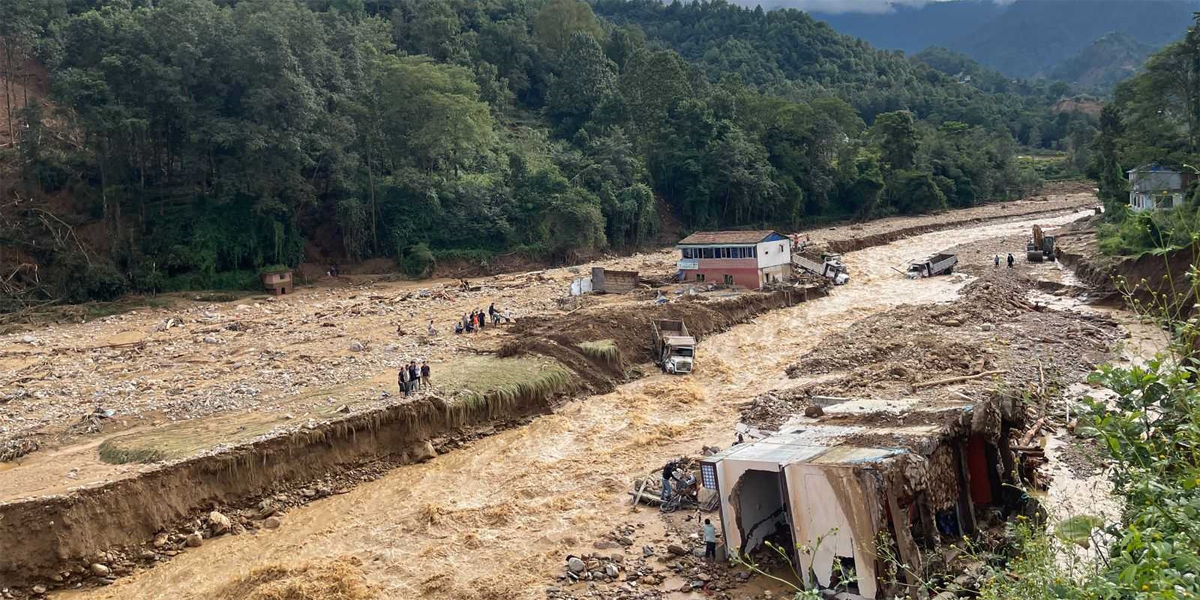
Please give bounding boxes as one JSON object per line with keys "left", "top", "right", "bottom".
{"left": 1046, "top": 32, "right": 1158, "bottom": 92}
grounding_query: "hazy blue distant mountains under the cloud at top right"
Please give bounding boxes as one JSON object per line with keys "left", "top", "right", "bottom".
{"left": 814, "top": 0, "right": 1200, "bottom": 89}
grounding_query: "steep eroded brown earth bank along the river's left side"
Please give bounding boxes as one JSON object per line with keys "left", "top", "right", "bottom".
{"left": 0, "top": 289, "right": 824, "bottom": 588}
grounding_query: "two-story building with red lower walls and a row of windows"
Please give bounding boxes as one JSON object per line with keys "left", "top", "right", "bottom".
{"left": 676, "top": 230, "right": 792, "bottom": 289}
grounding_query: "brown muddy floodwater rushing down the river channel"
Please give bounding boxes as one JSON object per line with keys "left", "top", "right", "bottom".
{"left": 63, "top": 211, "right": 1113, "bottom": 600}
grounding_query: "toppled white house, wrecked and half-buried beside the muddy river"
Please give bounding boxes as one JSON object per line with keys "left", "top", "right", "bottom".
{"left": 701, "top": 400, "right": 1021, "bottom": 599}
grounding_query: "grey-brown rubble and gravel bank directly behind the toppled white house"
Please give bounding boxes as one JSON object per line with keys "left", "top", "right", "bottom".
{"left": 763, "top": 270, "right": 1123, "bottom": 410}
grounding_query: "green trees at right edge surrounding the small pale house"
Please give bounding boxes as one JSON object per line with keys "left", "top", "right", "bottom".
{"left": 1092, "top": 13, "right": 1200, "bottom": 254}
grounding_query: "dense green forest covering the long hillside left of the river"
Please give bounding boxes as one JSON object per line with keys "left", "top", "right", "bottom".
{"left": 0, "top": 0, "right": 1070, "bottom": 308}
